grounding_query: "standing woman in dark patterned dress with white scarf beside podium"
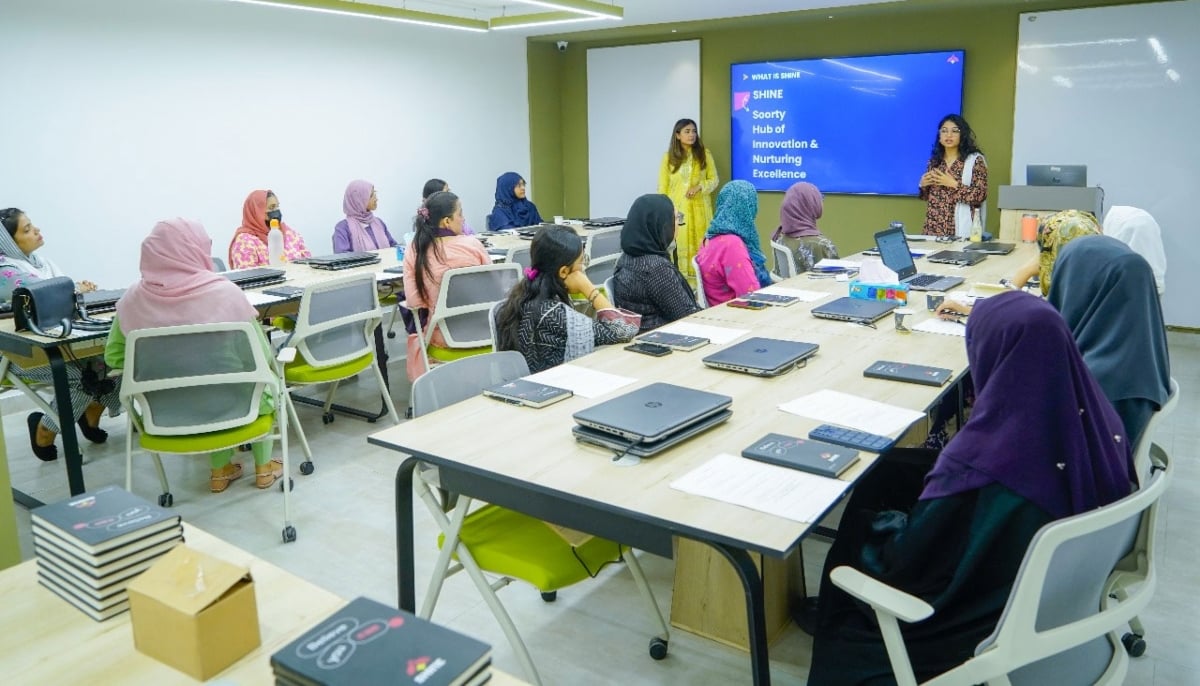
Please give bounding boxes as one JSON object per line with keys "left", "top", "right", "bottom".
{"left": 919, "top": 114, "right": 988, "bottom": 237}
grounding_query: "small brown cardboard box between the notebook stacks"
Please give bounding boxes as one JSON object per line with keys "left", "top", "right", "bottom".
{"left": 128, "top": 544, "right": 262, "bottom": 681}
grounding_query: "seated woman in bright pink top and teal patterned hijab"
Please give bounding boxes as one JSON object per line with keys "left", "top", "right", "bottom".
{"left": 696, "top": 181, "right": 770, "bottom": 307}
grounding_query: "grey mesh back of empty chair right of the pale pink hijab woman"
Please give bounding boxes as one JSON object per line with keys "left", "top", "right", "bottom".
{"left": 289, "top": 273, "right": 383, "bottom": 367}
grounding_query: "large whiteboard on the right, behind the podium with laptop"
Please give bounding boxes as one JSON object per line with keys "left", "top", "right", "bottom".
{"left": 1013, "top": 0, "right": 1200, "bottom": 327}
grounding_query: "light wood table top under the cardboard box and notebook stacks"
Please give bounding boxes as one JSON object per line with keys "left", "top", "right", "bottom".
{"left": 0, "top": 524, "right": 523, "bottom": 686}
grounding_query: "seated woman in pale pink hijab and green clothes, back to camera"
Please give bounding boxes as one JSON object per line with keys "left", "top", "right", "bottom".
{"left": 104, "top": 217, "right": 283, "bottom": 493}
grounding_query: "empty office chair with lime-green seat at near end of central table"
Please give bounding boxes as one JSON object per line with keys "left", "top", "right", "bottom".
{"left": 413, "top": 350, "right": 670, "bottom": 685}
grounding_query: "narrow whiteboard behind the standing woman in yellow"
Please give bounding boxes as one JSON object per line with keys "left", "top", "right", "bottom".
{"left": 588, "top": 41, "right": 704, "bottom": 217}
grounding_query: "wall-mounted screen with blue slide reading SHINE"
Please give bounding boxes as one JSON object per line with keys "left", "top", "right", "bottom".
{"left": 731, "top": 50, "right": 964, "bottom": 195}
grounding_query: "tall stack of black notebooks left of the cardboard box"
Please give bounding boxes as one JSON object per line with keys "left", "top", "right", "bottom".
{"left": 32, "top": 486, "right": 184, "bottom": 621}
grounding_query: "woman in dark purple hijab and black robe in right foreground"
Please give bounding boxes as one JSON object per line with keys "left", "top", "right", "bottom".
{"left": 809, "top": 291, "right": 1133, "bottom": 686}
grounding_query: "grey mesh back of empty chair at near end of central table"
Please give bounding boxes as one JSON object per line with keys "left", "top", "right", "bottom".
{"left": 412, "top": 350, "right": 529, "bottom": 417}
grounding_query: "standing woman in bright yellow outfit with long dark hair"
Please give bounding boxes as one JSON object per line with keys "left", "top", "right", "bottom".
{"left": 659, "top": 119, "right": 719, "bottom": 277}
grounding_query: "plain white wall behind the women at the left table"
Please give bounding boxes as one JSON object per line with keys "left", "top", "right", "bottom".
{"left": 0, "top": 0, "right": 529, "bottom": 288}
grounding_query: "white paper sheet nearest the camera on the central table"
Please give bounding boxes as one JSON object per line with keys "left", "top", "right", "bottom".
{"left": 671, "top": 453, "right": 850, "bottom": 522}
